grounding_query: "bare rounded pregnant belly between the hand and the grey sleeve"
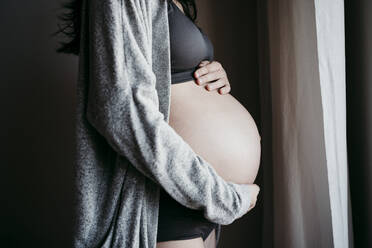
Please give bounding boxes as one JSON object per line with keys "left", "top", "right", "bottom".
{"left": 169, "top": 81, "right": 261, "bottom": 183}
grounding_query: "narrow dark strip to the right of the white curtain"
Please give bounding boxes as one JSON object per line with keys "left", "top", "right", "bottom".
{"left": 345, "top": 0, "right": 372, "bottom": 247}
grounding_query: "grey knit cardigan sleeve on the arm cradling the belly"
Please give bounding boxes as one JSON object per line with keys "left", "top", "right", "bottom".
{"left": 86, "top": 0, "right": 251, "bottom": 225}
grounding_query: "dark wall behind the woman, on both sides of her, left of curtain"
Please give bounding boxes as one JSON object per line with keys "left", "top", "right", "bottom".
{"left": 0, "top": 0, "right": 263, "bottom": 248}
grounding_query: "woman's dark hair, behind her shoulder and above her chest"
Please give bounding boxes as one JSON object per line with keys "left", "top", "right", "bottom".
{"left": 52, "top": 0, "right": 197, "bottom": 55}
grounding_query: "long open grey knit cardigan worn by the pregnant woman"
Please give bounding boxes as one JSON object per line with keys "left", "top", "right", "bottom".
{"left": 73, "top": 0, "right": 251, "bottom": 248}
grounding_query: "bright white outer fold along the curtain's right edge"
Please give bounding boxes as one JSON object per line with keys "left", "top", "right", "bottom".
{"left": 315, "top": 0, "right": 349, "bottom": 247}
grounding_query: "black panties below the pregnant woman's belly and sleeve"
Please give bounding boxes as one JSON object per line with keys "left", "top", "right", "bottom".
{"left": 157, "top": 188, "right": 217, "bottom": 242}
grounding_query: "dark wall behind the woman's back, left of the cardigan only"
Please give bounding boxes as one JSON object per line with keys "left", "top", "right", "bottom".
{"left": 0, "top": 0, "right": 77, "bottom": 247}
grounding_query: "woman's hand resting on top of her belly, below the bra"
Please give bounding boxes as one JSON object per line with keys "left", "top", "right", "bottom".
{"left": 194, "top": 60, "right": 231, "bottom": 95}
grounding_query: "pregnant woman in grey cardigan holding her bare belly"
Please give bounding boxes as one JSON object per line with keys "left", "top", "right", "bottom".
{"left": 54, "top": 0, "right": 260, "bottom": 248}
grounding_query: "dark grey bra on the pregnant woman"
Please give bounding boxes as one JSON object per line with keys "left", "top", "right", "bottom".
{"left": 168, "top": 0, "right": 213, "bottom": 84}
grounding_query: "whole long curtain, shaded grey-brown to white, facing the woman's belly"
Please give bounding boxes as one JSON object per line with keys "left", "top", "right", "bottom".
{"left": 258, "top": 0, "right": 352, "bottom": 248}
